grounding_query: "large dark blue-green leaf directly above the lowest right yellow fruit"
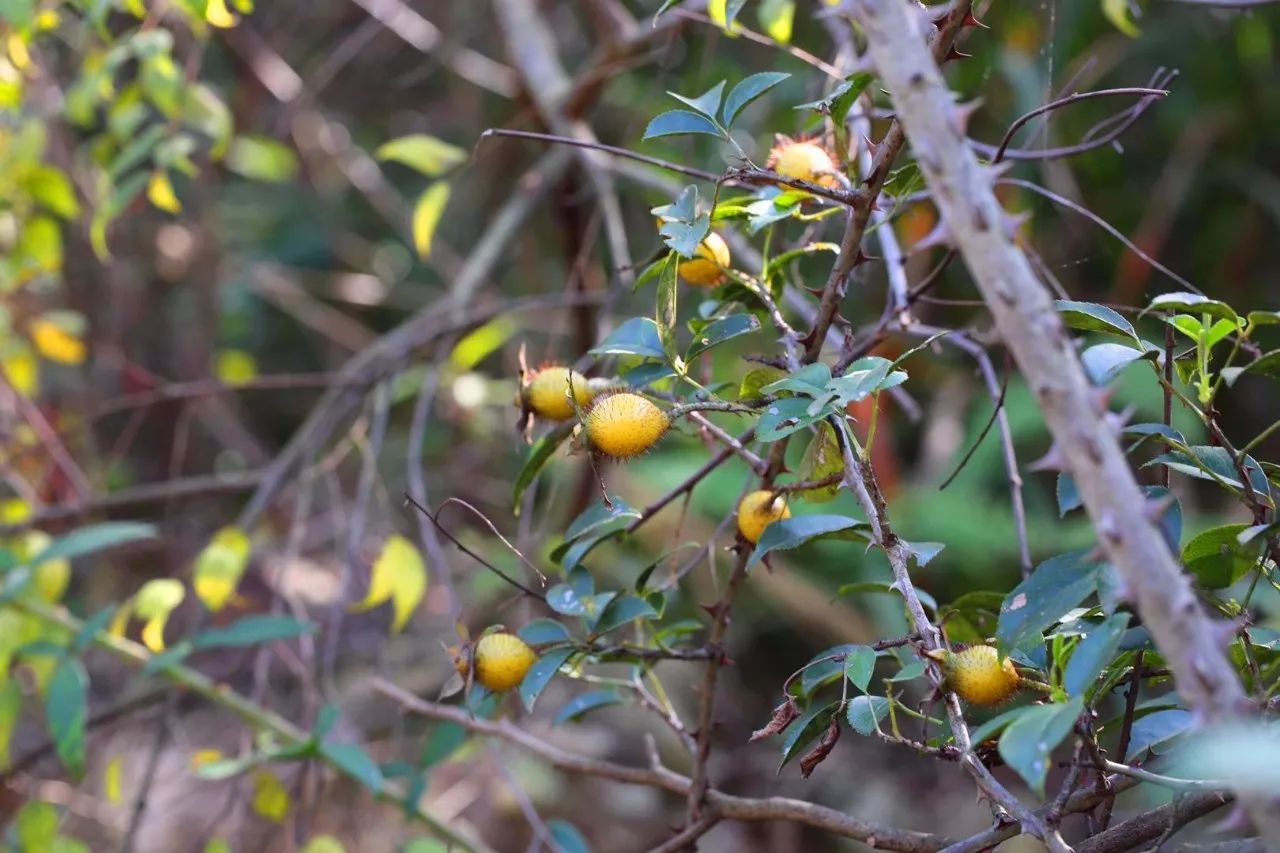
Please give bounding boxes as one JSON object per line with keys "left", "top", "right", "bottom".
{"left": 996, "top": 551, "right": 1102, "bottom": 651}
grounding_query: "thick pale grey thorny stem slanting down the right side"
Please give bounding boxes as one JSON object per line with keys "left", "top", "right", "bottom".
{"left": 839, "top": 0, "right": 1280, "bottom": 844}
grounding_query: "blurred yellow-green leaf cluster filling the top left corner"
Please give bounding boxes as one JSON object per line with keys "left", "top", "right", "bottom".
{"left": 0, "top": 0, "right": 297, "bottom": 396}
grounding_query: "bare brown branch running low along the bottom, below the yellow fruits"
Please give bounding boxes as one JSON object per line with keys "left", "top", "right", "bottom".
{"left": 372, "top": 679, "right": 950, "bottom": 853}
